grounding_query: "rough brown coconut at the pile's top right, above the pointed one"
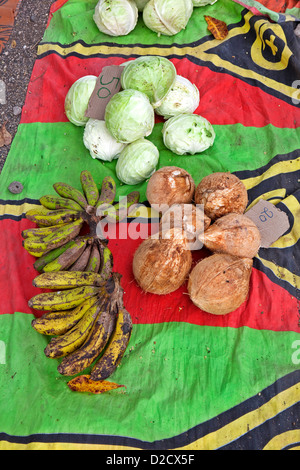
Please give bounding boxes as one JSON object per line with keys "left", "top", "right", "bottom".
{"left": 195, "top": 172, "right": 248, "bottom": 220}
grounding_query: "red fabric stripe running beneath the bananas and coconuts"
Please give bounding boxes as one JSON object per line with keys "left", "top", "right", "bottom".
{"left": 0, "top": 219, "right": 300, "bottom": 332}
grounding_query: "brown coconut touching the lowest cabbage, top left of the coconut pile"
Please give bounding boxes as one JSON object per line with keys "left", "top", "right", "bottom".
{"left": 146, "top": 166, "right": 195, "bottom": 213}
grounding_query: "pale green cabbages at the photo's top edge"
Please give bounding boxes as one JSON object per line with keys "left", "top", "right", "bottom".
{"left": 93, "top": 0, "right": 217, "bottom": 36}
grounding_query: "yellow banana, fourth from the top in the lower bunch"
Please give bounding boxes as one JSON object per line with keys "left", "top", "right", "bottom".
{"left": 44, "top": 302, "right": 100, "bottom": 358}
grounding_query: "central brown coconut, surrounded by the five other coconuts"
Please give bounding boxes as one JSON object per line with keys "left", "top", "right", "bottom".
{"left": 160, "top": 204, "right": 211, "bottom": 250}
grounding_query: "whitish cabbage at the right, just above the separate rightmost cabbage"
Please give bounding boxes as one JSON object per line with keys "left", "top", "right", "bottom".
{"left": 155, "top": 75, "right": 200, "bottom": 119}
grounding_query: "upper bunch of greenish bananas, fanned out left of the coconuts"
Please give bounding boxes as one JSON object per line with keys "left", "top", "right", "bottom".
{"left": 22, "top": 170, "right": 139, "bottom": 274}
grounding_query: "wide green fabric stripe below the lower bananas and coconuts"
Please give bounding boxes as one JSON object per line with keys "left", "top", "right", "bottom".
{"left": 0, "top": 313, "right": 298, "bottom": 441}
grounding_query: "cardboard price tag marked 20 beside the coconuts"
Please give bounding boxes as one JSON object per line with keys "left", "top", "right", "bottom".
{"left": 245, "top": 200, "right": 290, "bottom": 248}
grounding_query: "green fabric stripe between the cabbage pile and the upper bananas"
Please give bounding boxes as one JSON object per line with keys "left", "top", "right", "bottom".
{"left": 0, "top": 122, "right": 300, "bottom": 201}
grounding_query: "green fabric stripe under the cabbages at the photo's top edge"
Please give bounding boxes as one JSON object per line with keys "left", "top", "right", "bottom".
{"left": 43, "top": 0, "right": 243, "bottom": 45}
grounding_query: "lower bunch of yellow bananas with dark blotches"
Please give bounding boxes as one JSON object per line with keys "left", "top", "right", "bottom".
{"left": 28, "top": 271, "right": 132, "bottom": 381}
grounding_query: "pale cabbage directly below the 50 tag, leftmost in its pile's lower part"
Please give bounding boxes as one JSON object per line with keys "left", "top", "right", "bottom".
{"left": 83, "top": 119, "right": 126, "bottom": 162}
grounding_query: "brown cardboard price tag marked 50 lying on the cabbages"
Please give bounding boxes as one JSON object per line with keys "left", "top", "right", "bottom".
{"left": 85, "top": 65, "right": 124, "bottom": 121}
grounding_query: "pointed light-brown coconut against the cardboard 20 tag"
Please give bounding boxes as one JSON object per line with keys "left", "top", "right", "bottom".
{"left": 198, "top": 214, "right": 261, "bottom": 258}
